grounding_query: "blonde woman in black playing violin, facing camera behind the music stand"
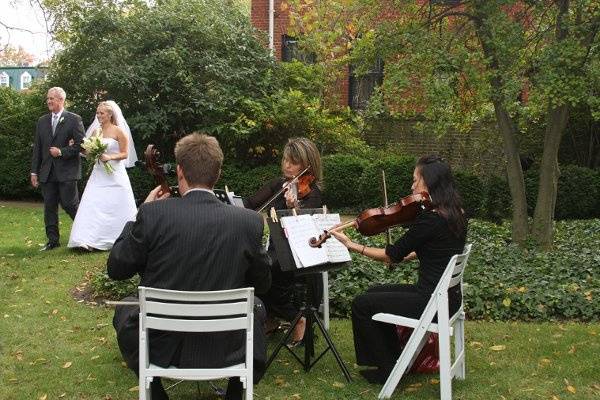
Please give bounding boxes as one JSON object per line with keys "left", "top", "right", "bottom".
{"left": 244, "top": 138, "right": 323, "bottom": 342}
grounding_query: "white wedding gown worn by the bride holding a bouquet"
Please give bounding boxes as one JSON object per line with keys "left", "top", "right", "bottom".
{"left": 68, "top": 138, "right": 137, "bottom": 250}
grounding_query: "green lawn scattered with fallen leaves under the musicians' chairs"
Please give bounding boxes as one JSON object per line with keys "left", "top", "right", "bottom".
{"left": 0, "top": 203, "right": 600, "bottom": 400}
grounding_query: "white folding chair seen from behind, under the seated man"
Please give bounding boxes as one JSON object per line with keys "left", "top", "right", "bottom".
{"left": 139, "top": 286, "right": 254, "bottom": 400}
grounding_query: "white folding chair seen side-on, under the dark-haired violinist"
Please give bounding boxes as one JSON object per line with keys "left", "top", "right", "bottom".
{"left": 372, "top": 244, "right": 471, "bottom": 400}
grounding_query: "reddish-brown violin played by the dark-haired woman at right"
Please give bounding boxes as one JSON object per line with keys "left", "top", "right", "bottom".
{"left": 309, "top": 192, "right": 432, "bottom": 247}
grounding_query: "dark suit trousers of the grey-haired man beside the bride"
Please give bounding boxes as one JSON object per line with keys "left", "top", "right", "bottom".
{"left": 41, "top": 169, "right": 79, "bottom": 244}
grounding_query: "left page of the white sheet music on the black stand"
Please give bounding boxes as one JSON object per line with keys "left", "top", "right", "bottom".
{"left": 280, "top": 214, "right": 329, "bottom": 268}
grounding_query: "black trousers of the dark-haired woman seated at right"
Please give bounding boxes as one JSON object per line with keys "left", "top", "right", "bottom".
{"left": 352, "top": 285, "right": 460, "bottom": 369}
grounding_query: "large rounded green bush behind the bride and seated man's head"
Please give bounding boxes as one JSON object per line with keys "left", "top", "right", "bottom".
{"left": 49, "top": 0, "right": 273, "bottom": 153}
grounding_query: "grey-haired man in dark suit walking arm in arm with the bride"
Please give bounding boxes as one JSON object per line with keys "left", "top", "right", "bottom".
{"left": 31, "top": 87, "right": 84, "bottom": 250}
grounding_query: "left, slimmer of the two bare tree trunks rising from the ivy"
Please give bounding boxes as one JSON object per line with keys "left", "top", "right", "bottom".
{"left": 494, "top": 101, "right": 529, "bottom": 244}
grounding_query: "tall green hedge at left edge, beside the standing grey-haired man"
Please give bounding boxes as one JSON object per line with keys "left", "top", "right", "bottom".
{"left": 0, "top": 87, "right": 48, "bottom": 199}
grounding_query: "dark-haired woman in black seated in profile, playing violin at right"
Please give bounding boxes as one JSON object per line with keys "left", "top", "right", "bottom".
{"left": 331, "top": 156, "right": 467, "bottom": 383}
